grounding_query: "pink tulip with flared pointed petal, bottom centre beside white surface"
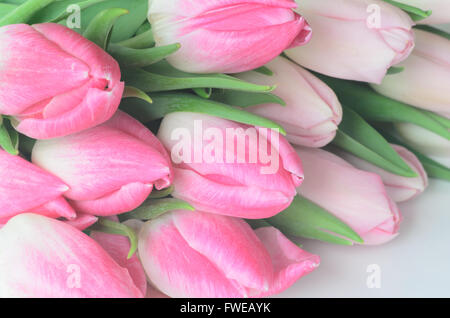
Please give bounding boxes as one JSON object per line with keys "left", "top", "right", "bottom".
{"left": 138, "top": 211, "right": 320, "bottom": 298}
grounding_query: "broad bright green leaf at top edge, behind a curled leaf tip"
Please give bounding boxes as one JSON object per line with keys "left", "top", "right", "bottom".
{"left": 70, "top": 0, "right": 148, "bottom": 43}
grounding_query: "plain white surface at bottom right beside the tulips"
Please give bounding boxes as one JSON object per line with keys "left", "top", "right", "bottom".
{"left": 278, "top": 180, "right": 450, "bottom": 297}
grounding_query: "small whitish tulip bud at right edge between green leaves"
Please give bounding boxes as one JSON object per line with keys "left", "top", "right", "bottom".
{"left": 395, "top": 123, "right": 450, "bottom": 159}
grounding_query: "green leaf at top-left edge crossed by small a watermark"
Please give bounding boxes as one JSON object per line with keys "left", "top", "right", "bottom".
{"left": 29, "top": 0, "right": 106, "bottom": 24}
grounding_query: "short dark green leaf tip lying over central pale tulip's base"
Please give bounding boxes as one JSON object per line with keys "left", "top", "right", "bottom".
{"left": 211, "top": 89, "right": 286, "bottom": 107}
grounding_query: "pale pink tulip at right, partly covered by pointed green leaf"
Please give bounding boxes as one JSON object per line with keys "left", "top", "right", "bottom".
{"left": 339, "top": 145, "right": 428, "bottom": 202}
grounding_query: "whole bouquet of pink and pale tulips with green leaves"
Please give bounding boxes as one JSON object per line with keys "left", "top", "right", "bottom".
{"left": 0, "top": 0, "right": 450, "bottom": 298}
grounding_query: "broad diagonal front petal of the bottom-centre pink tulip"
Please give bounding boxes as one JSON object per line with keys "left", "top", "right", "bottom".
{"left": 172, "top": 211, "right": 273, "bottom": 290}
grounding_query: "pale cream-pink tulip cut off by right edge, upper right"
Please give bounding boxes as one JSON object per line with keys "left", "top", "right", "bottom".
{"left": 373, "top": 30, "right": 450, "bottom": 117}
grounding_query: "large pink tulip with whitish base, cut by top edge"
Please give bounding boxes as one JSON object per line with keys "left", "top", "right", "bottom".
{"left": 148, "top": 0, "right": 311, "bottom": 73}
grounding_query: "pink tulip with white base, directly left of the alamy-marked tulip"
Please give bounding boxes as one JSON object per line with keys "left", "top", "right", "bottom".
{"left": 32, "top": 111, "right": 172, "bottom": 216}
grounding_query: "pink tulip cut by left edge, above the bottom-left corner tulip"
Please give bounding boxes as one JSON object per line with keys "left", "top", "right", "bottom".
{"left": 0, "top": 150, "right": 76, "bottom": 224}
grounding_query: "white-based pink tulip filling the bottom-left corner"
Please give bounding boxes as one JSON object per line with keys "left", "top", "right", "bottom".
{"left": 0, "top": 214, "right": 143, "bottom": 298}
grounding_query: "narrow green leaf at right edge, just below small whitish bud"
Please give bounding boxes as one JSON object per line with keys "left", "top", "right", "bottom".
{"left": 379, "top": 129, "right": 450, "bottom": 181}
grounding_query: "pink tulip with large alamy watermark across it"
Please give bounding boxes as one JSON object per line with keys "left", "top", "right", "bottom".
{"left": 158, "top": 112, "right": 303, "bottom": 219}
